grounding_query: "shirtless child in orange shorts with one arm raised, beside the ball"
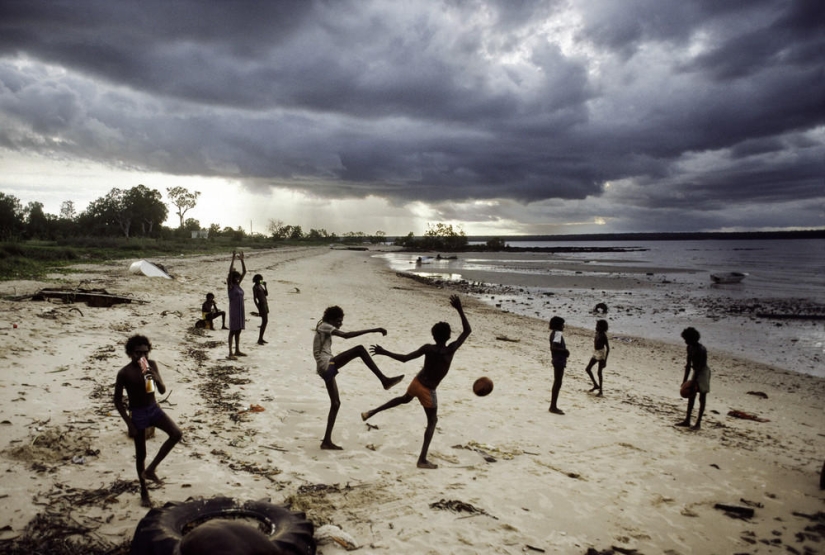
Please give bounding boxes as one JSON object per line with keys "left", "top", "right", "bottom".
{"left": 361, "top": 295, "right": 472, "bottom": 469}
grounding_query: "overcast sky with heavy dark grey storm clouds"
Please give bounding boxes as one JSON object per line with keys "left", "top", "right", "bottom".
{"left": 0, "top": 0, "right": 825, "bottom": 235}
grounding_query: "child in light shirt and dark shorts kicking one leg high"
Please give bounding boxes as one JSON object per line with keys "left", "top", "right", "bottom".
{"left": 312, "top": 306, "right": 404, "bottom": 449}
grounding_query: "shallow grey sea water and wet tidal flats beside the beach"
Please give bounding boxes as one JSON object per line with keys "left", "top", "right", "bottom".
{"left": 376, "top": 239, "right": 825, "bottom": 377}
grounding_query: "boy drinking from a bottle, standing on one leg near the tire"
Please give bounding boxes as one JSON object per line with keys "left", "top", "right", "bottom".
{"left": 115, "top": 335, "right": 181, "bottom": 507}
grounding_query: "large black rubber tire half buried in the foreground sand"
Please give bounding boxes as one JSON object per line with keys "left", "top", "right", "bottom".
{"left": 130, "top": 497, "right": 316, "bottom": 555}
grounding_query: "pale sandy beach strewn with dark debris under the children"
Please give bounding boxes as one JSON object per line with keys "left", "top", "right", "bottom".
{"left": 0, "top": 248, "right": 825, "bottom": 555}
